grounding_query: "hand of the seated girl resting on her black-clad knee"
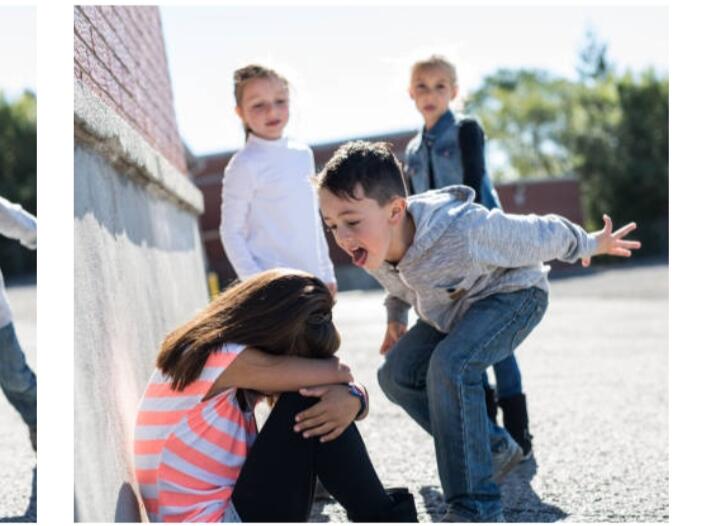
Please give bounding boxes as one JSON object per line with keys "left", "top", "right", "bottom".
{"left": 294, "top": 384, "right": 361, "bottom": 442}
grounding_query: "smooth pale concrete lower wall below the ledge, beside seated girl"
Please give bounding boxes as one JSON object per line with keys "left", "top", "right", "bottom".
{"left": 74, "top": 144, "right": 208, "bottom": 522}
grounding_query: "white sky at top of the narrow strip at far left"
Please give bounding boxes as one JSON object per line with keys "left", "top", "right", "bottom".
{"left": 0, "top": 6, "right": 36, "bottom": 98}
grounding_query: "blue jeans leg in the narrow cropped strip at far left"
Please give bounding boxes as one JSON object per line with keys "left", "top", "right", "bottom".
{"left": 0, "top": 323, "right": 37, "bottom": 428}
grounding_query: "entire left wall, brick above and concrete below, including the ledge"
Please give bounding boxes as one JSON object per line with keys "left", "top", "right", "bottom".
{"left": 74, "top": 7, "right": 208, "bottom": 522}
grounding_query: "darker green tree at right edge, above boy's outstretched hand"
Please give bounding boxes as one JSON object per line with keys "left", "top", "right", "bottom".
{"left": 571, "top": 70, "right": 669, "bottom": 253}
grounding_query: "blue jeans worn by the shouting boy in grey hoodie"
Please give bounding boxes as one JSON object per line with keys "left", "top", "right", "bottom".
{"left": 377, "top": 288, "right": 547, "bottom": 521}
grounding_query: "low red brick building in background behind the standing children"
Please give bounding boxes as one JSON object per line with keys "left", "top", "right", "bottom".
{"left": 190, "top": 130, "right": 583, "bottom": 286}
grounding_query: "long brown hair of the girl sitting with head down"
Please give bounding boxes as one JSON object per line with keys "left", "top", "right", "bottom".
{"left": 157, "top": 269, "right": 340, "bottom": 390}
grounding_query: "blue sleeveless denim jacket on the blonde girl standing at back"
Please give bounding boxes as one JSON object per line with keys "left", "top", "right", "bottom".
{"left": 404, "top": 110, "right": 501, "bottom": 210}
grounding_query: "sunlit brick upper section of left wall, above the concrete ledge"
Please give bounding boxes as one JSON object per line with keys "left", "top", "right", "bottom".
{"left": 75, "top": 6, "right": 187, "bottom": 173}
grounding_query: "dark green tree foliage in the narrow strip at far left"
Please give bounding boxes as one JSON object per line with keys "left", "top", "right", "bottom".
{"left": 0, "top": 92, "right": 36, "bottom": 274}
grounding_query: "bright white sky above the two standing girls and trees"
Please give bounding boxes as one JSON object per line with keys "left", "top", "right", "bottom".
{"left": 161, "top": 6, "right": 668, "bottom": 154}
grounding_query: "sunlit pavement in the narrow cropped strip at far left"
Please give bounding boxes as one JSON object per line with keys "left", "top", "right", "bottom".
{"left": 0, "top": 283, "right": 37, "bottom": 522}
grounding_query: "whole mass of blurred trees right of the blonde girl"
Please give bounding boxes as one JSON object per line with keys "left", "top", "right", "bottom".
{"left": 466, "top": 33, "right": 669, "bottom": 253}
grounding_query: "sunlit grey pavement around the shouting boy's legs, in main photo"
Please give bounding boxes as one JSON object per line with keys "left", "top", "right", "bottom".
{"left": 312, "top": 265, "right": 669, "bottom": 522}
